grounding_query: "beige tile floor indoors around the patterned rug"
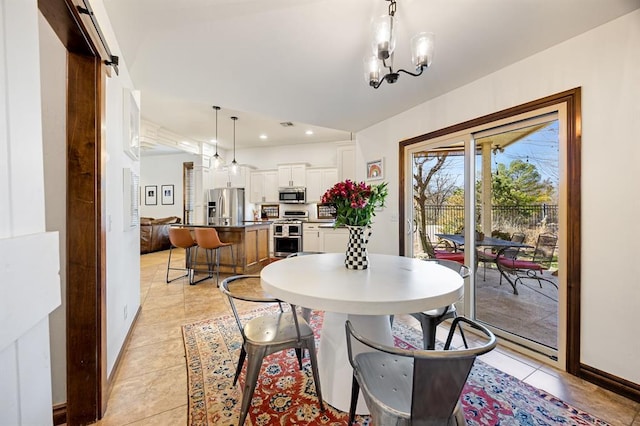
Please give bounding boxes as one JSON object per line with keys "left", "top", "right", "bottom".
{"left": 98, "top": 252, "right": 640, "bottom": 426}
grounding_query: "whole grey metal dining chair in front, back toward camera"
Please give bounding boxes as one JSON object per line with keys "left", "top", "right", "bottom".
{"left": 345, "top": 317, "right": 496, "bottom": 426}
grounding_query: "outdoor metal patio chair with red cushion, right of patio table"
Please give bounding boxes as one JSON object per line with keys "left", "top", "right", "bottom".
{"left": 496, "top": 234, "right": 558, "bottom": 290}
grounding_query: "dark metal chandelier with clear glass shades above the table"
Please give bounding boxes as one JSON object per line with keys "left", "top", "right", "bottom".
{"left": 364, "top": 0, "right": 434, "bottom": 89}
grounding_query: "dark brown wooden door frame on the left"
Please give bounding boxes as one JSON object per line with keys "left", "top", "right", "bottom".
{"left": 38, "top": 0, "right": 108, "bottom": 424}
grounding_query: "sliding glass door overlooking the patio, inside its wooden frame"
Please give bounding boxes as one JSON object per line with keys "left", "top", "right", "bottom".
{"left": 404, "top": 102, "right": 566, "bottom": 362}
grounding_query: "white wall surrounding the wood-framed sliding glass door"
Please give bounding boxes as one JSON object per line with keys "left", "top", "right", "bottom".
{"left": 356, "top": 10, "right": 640, "bottom": 383}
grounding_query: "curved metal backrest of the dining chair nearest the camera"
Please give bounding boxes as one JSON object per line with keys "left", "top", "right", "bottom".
{"left": 345, "top": 317, "right": 497, "bottom": 425}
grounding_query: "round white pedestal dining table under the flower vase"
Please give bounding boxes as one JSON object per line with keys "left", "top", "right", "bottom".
{"left": 260, "top": 253, "right": 464, "bottom": 414}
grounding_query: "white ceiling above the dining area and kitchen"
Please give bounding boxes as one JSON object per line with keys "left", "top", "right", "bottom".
{"left": 104, "top": 0, "right": 640, "bottom": 153}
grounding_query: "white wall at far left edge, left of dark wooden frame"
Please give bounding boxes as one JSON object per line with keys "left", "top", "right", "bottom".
{"left": 0, "top": 0, "right": 60, "bottom": 425}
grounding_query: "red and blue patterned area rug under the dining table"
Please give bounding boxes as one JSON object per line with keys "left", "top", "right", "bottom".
{"left": 182, "top": 308, "right": 607, "bottom": 426}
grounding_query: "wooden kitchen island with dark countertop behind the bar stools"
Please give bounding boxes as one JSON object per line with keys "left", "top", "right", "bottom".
{"left": 176, "top": 221, "right": 271, "bottom": 274}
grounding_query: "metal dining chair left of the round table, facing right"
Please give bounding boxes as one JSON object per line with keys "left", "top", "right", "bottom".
{"left": 220, "top": 275, "right": 324, "bottom": 426}
